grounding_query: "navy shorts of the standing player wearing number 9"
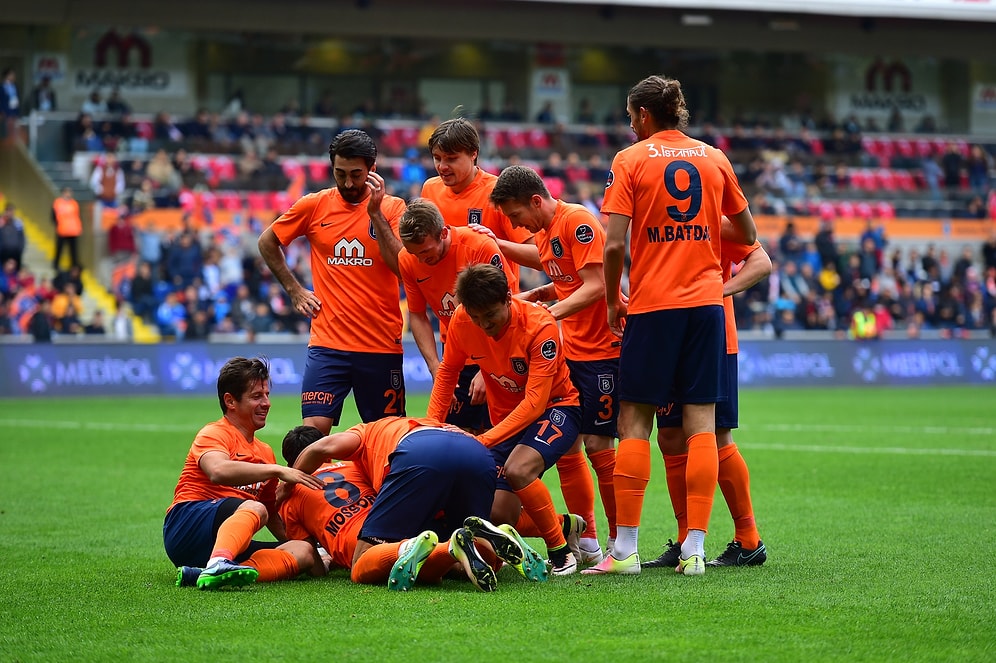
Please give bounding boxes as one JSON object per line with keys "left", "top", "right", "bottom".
{"left": 619, "top": 305, "right": 727, "bottom": 407}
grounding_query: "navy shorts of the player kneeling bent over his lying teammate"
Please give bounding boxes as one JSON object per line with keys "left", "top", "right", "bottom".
{"left": 360, "top": 428, "right": 495, "bottom": 543}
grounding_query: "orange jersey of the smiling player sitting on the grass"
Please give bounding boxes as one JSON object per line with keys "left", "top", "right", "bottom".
{"left": 167, "top": 417, "right": 277, "bottom": 511}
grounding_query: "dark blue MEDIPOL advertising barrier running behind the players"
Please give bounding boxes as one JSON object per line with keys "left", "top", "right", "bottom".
{"left": 0, "top": 339, "right": 996, "bottom": 398}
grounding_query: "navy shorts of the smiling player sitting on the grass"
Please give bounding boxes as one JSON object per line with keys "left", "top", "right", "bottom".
{"left": 163, "top": 497, "right": 280, "bottom": 567}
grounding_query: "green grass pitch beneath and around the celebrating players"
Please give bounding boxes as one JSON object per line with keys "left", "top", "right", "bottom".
{"left": 0, "top": 387, "right": 996, "bottom": 663}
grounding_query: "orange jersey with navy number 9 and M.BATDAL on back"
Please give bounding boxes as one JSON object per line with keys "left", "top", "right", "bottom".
{"left": 602, "top": 131, "right": 747, "bottom": 313}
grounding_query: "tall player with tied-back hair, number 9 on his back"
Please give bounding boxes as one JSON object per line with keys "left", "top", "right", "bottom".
{"left": 585, "top": 76, "right": 757, "bottom": 575}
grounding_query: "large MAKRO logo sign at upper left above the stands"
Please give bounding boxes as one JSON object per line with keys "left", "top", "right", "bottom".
{"left": 75, "top": 30, "right": 170, "bottom": 91}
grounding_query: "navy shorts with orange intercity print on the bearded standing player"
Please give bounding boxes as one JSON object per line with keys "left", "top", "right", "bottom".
{"left": 301, "top": 346, "right": 406, "bottom": 426}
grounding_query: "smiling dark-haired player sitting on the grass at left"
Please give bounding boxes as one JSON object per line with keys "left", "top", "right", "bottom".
{"left": 163, "top": 357, "right": 324, "bottom": 589}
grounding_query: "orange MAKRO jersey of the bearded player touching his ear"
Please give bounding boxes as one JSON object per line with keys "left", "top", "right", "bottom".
{"left": 273, "top": 188, "right": 405, "bottom": 354}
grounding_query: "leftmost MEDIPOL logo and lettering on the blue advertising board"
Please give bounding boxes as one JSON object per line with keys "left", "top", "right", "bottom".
{"left": 18, "top": 355, "right": 157, "bottom": 394}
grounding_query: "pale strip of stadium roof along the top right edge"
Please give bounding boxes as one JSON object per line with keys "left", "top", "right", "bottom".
{"left": 517, "top": 0, "right": 996, "bottom": 22}
